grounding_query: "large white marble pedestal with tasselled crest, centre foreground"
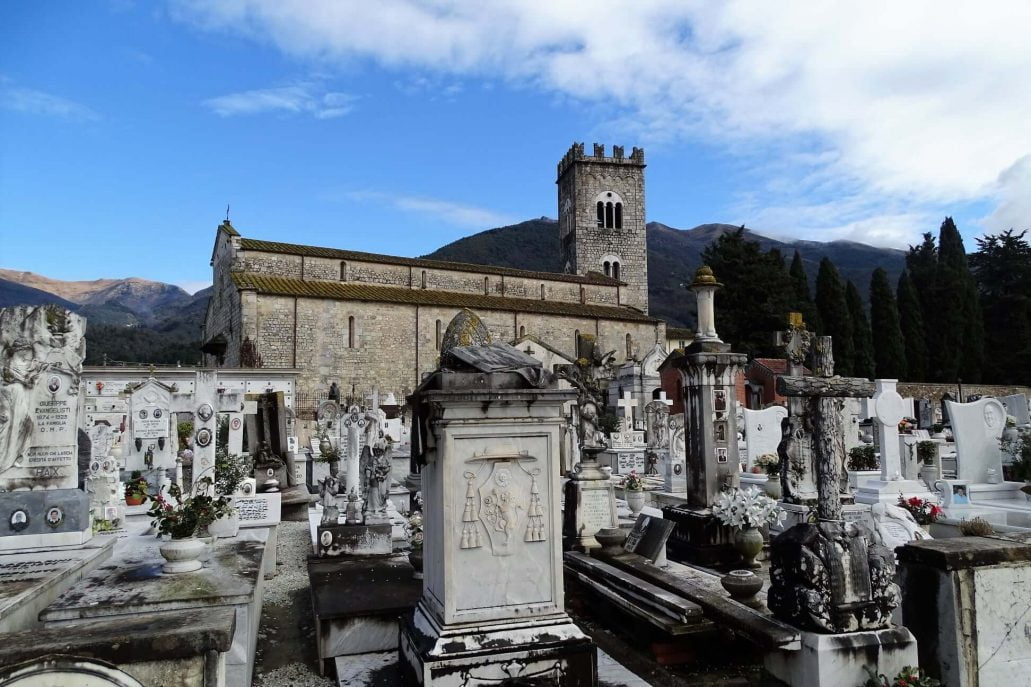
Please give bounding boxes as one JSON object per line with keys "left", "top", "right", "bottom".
{"left": 400, "top": 369, "right": 596, "bottom": 687}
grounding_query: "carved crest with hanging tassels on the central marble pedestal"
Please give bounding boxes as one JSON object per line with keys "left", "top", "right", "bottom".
{"left": 459, "top": 453, "right": 547, "bottom": 556}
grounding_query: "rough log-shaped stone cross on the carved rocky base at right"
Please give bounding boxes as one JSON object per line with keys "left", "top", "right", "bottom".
{"left": 776, "top": 336, "right": 874, "bottom": 520}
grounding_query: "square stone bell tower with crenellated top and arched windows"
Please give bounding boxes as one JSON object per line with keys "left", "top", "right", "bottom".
{"left": 557, "top": 143, "right": 647, "bottom": 313}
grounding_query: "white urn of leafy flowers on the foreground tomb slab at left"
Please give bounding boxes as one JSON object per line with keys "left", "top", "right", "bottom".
{"left": 147, "top": 478, "right": 230, "bottom": 574}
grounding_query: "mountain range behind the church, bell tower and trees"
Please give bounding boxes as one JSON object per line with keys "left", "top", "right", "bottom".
{"left": 0, "top": 218, "right": 905, "bottom": 364}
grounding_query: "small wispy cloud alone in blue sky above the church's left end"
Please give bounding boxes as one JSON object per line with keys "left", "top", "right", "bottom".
{"left": 204, "top": 83, "right": 358, "bottom": 120}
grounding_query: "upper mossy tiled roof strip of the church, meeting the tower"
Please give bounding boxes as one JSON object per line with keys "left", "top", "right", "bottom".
{"left": 240, "top": 238, "right": 624, "bottom": 287}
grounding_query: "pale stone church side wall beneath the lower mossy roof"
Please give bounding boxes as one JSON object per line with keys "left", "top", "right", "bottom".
{"left": 243, "top": 292, "right": 665, "bottom": 394}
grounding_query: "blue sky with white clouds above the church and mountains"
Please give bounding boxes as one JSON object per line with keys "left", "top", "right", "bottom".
{"left": 0, "top": 0, "right": 1031, "bottom": 291}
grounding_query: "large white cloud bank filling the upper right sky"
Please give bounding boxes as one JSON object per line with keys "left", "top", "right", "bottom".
{"left": 175, "top": 0, "right": 1031, "bottom": 242}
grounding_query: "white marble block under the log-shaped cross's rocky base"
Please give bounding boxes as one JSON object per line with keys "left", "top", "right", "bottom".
{"left": 763, "top": 627, "right": 918, "bottom": 687}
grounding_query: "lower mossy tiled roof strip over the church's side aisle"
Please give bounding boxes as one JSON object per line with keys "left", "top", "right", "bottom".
{"left": 232, "top": 272, "right": 661, "bottom": 323}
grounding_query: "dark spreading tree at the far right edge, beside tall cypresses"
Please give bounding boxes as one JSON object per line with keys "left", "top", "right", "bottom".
{"left": 970, "top": 229, "right": 1031, "bottom": 384}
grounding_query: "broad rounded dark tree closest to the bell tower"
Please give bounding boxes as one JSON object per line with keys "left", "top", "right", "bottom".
{"left": 702, "top": 227, "right": 792, "bottom": 356}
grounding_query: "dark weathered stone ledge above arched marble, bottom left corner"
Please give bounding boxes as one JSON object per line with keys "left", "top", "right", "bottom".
{"left": 0, "top": 609, "right": 236, "bottom": 665}
